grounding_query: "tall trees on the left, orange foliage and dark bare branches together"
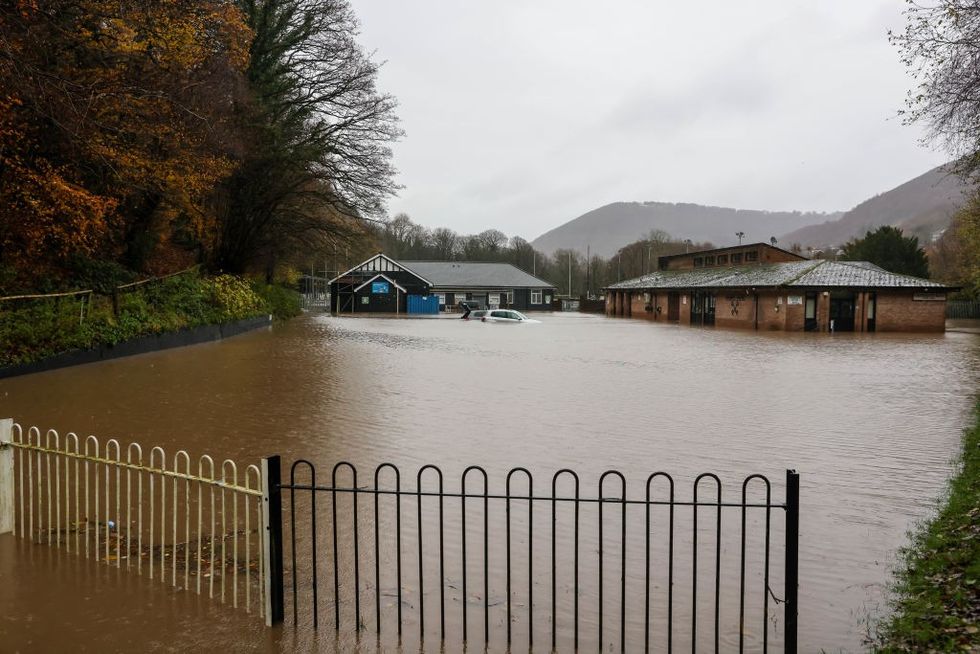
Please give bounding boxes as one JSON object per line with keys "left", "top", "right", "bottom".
{"left": 0, "top": 0, "right": 400, "bottom": 291}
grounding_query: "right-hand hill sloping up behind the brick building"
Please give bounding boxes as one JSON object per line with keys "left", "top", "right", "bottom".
{"left": 780, "top": 166, "right": 970, "bottom": 247}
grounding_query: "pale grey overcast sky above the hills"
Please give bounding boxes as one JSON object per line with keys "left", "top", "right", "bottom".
{"left": 353, "top": 0, "right": 944, "bottom": 240}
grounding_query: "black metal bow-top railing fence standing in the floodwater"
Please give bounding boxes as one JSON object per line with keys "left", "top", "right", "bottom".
{"left": 269, "top": 457, "right": 799, "bottom": 652}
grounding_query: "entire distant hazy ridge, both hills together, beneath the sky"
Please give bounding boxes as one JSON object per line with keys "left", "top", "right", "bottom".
{"left": 531, "top": 166, "right": 970, "bottom": 257}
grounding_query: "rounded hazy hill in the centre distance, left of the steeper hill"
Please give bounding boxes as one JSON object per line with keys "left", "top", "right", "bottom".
{"left": 531, "top": 202, "right": 842, "bottom": 257}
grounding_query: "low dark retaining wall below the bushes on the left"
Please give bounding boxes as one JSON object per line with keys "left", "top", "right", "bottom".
{"left": 0, "top": 316, "right": 272, "bottom": 379}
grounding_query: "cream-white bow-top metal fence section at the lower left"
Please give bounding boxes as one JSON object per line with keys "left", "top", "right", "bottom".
{"left": 0, "top": 419, "right": 267, "bottom": 617}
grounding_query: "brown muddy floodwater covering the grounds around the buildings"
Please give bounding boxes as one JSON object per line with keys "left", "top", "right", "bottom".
{"left": 0, "top": 314, "right": 980, "bottom": 652}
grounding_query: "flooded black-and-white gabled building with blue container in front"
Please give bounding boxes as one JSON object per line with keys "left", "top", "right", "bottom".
{"left": 330, "top": 254, "right": 555, "bottom": 314}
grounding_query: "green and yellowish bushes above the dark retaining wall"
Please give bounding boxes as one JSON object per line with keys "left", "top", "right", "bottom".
{"left": 0, "top": 272, "right": 300, "bottom": 366}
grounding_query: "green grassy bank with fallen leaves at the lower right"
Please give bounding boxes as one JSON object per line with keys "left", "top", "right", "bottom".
{"left": 872, "top": 402, "right": 980, "bottom": 652}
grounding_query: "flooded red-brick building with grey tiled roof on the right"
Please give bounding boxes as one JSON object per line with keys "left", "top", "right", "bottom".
{"left": 606, "top": 243, "right": 951, "bottom": 332}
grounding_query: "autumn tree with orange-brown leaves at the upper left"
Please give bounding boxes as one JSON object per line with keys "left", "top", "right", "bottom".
{"left": 0, "top": 0, "right": 250, "bottom": 288}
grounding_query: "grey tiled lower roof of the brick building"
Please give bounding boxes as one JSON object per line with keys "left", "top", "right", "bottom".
{"left": 609, "top": 261, "right": 945, "bottom": 290}
